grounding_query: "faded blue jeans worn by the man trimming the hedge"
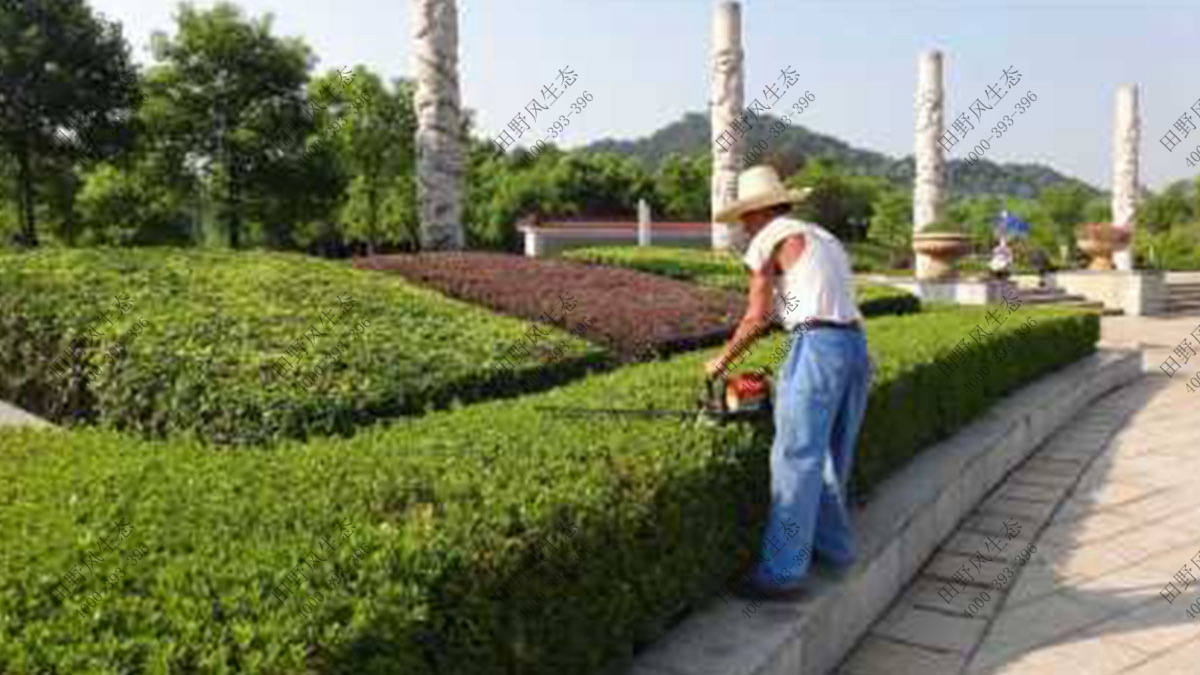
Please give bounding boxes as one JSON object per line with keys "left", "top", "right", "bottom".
{"left": 754, "top": 328, "right": 870, "bottom": 589}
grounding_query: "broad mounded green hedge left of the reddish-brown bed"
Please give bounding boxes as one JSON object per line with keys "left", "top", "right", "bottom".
{"left": 0, "top": 249, "right": 604, "bottom": 443}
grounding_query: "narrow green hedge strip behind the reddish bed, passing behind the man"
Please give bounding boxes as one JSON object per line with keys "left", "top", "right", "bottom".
{"left": 563, "top": 246, "right": 920, "bottom": 316}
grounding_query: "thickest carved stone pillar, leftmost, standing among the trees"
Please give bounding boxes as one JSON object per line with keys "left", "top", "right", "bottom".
{"left": 413, "top": 0, "right": 464, "bottom": 250}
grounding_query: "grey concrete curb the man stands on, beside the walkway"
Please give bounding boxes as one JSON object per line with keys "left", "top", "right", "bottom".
{"left": 628, "top": 350, "right": 1142, "bottom": 675}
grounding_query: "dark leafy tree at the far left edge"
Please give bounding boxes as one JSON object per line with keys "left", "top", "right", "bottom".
{"left": 0, "top": 0, "right": 136, "bottom": 246}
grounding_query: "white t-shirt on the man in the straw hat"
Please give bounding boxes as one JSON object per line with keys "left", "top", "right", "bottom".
{"left": 743, "top": 217, "right": 863, "bottom": 330}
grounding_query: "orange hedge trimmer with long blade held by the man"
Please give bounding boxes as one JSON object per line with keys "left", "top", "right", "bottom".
{"left": 534, "top": 372, "right": 772, "bottom": 424}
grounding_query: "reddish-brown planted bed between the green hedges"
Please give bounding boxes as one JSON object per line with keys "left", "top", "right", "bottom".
{"left": 354, "top": 252, "right": 744, "bottom": 360}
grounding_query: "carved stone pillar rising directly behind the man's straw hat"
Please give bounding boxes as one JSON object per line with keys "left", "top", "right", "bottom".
{"left": 709, "top": 1, "right": 745, "bottom": 250}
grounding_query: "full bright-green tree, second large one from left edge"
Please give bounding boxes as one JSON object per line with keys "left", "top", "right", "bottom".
{"left": 148, "top": 2, "right": 324, "bottom": 249}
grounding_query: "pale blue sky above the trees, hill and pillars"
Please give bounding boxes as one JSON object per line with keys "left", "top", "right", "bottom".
{"left": 91, "top": 0, "right": 1200, "bottom": 189}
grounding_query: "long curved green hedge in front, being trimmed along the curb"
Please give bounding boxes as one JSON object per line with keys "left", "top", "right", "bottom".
{"left": 0, "top": 307, "right": 1098, "bottom": 675}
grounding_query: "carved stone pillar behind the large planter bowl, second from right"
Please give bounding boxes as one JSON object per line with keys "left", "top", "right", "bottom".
{"left": 912, "top": 50, "right": 946, "bottom": 279}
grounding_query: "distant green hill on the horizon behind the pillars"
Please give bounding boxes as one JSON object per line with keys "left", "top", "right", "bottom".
{"left": 586, "top": 113, "right": 1100, "bottom": 198}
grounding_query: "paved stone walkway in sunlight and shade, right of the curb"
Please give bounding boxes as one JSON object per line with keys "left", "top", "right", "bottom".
{"left": 839, "top": 317, "right": 1200, "bottom": 675}
